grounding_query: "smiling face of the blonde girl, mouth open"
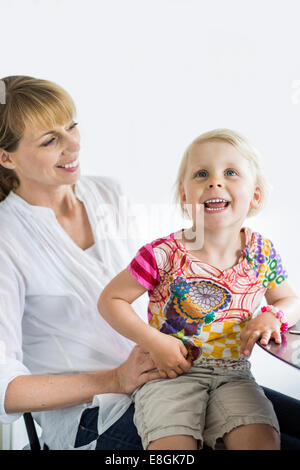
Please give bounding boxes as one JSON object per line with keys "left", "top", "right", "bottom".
{"left": 180, "top": 141, "right": 262, "bottom": 230}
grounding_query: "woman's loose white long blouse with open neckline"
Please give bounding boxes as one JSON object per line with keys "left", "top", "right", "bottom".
{"left": 0, "top": 176, "right": 147, "bottom": 449}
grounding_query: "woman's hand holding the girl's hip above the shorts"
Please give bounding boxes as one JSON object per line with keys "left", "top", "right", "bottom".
{"left": 115, "top": 346, "right": 161, "bottom": 393}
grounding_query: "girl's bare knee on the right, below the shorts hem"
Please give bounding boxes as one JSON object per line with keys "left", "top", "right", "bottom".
{"left": 223, "top": 424, "right": 280, "bottom": 450}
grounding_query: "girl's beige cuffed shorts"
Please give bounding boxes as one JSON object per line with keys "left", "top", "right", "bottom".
{"left": 132, "top": 366, "right": 279, "bottom": 449}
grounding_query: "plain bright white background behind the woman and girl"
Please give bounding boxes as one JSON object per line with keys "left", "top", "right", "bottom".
{"left": 0, "top": 0, "right": 300, "bottom": 448}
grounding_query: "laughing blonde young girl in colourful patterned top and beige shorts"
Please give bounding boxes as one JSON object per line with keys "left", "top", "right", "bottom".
{"left": 98, "top": 129, "right": 300, "bottom": 450}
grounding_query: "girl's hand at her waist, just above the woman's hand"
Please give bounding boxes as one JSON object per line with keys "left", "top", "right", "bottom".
{"left": 144, "top": 330, "right": 191, "bottom": 379}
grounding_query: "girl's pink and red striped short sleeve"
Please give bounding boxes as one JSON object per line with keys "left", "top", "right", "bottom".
{"left": 127, "top": 243, "right": 160, "bottom": 291}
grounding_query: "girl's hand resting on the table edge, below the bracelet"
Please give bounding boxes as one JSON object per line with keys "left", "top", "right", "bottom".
{"left": 240, "top": 312, "right": 281, "bottom": 358}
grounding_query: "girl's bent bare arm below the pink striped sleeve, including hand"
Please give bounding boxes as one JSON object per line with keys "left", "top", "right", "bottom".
{"left": 98, "top": 269, "right": 190, "bottom": 378}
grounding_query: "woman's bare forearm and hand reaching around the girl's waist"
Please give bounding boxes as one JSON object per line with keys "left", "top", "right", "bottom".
{"left": 4, "top": 346, "right": 160, "bottom": 413}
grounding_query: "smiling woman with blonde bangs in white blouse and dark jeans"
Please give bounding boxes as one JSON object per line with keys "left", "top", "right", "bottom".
{"left": 0, "top": 76, "right": 300, "bottom": 450}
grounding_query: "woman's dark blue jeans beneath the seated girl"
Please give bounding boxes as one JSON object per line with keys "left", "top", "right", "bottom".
{"left": 75, "top": 387, "right": 300, "bottom": 450}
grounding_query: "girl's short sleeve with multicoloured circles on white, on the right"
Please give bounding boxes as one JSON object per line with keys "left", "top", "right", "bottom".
{"left": 254, "top": 234, "right": 288, "bottom": 291}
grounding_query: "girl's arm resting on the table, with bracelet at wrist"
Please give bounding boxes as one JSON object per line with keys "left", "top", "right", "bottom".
{"left": 240, "top": 281, "right": 300, "bottom": 357}
